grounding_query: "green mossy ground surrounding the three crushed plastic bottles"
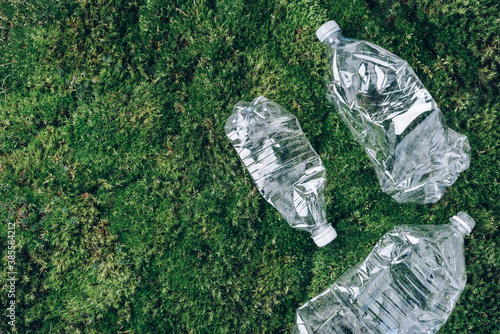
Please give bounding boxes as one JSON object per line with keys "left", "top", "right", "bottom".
{"left": 0, "top": 0, "right": 500, "bottom": 334}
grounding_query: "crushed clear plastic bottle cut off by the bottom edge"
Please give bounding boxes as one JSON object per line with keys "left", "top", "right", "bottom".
{"left": 293, "top": 212, "right": 475, "bottom": 334}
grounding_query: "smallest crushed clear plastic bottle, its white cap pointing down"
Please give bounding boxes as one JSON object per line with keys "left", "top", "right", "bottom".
{"left": 225, "top": 96, "right": 337, "bottom": 247}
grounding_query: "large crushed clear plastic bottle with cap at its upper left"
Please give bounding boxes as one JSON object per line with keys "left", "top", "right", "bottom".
{"left": 316, "top": 21, "right": 470, "bottom": 204}
